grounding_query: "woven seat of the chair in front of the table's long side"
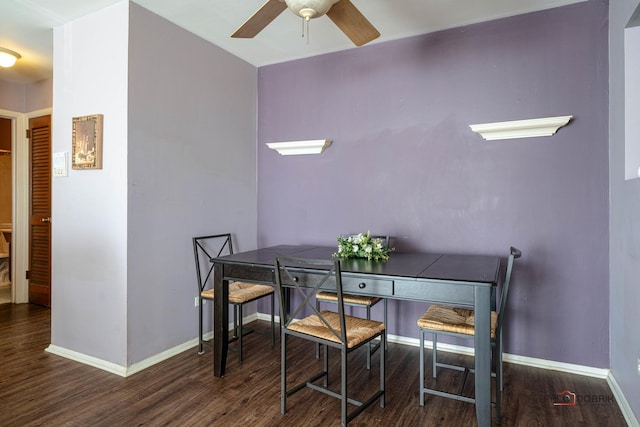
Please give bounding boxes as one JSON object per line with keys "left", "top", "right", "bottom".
{"left": 289, "top": 311, "right": 385, "bottom": 348}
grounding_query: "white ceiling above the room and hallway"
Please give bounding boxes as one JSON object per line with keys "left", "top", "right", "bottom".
{"left": 0, "top": 0, "right": 584, "bottom": 83}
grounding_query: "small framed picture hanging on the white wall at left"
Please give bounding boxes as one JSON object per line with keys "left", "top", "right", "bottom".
{"left": 71, "top": 114, "right": 103, "bottom": 169}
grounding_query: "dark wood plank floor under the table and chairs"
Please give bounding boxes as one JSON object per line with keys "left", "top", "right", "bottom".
{"left": 0, "top": 304, "right": 626, "bottom": 427}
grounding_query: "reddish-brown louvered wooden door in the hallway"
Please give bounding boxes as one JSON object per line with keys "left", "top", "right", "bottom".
{"left": 29, "top": 116, "right": 51, "bottom": 307}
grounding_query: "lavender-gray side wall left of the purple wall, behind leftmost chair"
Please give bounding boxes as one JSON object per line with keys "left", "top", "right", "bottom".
{"left": 127, "top": 3, "right": 257, "bottom": 362}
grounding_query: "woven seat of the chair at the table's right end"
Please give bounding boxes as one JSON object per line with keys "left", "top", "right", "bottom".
{"left": 418, "top": 305, "right": 498, "bottom": 339}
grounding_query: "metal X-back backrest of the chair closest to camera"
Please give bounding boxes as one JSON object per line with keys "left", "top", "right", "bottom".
{"left": 274, "top": 254, "right": 347, "bottom": 344}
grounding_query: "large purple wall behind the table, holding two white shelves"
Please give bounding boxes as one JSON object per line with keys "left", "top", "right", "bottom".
{"left": 258, "top": 1, "right": 609, "bottom": 368}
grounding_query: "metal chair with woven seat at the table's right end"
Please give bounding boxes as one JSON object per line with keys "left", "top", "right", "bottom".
{"left": 418, "top": 247, "right": 522, "bottom": 423}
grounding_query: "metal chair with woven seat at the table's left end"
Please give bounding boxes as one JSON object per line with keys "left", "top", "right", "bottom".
{"left": 192, "top": 233, "right": 275, "bottom": 363}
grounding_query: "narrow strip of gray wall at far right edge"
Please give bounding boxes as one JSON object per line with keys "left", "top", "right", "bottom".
{"left": 609, "top": 0, "right": 640, "bottom": 419}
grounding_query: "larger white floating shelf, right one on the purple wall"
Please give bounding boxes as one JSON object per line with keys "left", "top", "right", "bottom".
{"left": 469, "top": 116, "right": 573, "bottom": 140}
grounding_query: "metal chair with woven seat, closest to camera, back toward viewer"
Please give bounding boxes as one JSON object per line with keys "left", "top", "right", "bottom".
{"left": 274, "top": 254, "right": 386, "bottom": 426}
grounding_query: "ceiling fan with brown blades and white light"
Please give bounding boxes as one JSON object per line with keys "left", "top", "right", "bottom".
{"left": 231, "top": 0, "right": 380, "bottom": 46}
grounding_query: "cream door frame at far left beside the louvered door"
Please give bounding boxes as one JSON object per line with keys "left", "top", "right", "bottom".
{"left": 0, "top": 108, "right": 53, "bottom": 304}
